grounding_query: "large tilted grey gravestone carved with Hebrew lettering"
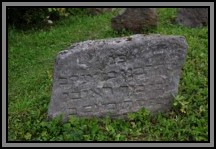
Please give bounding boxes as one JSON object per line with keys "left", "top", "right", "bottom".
{"left": 48, "top": 34, "right": 187, "bottom": 119}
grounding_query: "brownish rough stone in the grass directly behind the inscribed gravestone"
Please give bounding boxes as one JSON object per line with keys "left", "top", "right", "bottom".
{"left": 111, "top": 8, "right": 157, "bottom": 33}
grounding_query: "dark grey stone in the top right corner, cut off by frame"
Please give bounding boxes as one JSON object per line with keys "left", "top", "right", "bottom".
{"left": 176, "top": 8, "right": 208, "bottom": 27}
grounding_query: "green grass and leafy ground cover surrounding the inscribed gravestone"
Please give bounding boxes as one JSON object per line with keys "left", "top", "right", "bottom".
{"left": 8, "top": 8, "right": 209, "bottom": 141}
